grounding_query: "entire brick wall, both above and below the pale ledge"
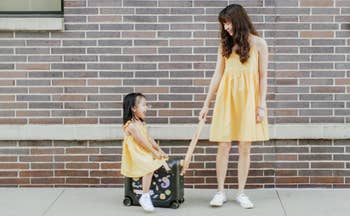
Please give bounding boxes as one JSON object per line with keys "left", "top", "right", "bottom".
{"left": 0, "top": 0, "right": 350, "bottom": 188}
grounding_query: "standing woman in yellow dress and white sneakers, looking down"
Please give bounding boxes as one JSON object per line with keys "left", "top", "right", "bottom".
{"left": 199, "top": 4, "right": 269, "bottom": 208}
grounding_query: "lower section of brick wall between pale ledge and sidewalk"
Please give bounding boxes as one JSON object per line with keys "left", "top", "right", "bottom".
{"left": 0, "top": 140, "right": 350, "bottom": 188}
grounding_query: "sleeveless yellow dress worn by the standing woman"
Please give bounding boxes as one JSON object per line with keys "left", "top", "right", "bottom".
{"left": 209, "top": 45, "right": 269, "bottom": 142}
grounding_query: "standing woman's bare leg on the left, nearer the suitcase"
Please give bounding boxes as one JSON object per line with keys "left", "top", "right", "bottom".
{"left": 216, "top": 142, "right": 231, "bottom": 191}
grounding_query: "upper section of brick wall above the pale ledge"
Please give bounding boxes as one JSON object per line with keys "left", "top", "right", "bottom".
{"left": 0, "top": 0, "right": 350, "bottom": 124}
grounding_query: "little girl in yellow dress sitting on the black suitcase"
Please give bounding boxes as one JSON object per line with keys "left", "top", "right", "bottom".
{"left": 121, "top": 93, "right": 168, "bottom": 211}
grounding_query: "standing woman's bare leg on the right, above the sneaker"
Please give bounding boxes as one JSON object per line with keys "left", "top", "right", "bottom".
{"left": 238, "top": 142, "right": 251, "bottom": 194}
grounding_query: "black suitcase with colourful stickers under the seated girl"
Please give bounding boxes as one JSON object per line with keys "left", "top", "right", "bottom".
{"left": 123, "top": 157, "right": 184, "bottom": 209}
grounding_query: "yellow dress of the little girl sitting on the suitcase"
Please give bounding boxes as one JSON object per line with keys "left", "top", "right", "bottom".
{"left": 121, "top": 121, "right": 165, "bottom": 178}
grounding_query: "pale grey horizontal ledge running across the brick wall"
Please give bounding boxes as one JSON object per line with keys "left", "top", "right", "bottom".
{"left": 0, "top": 124, "right": 350, "bottom": 140}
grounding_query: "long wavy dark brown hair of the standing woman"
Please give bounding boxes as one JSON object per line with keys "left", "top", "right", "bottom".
{"left": 218, "top": 4, "right": 259, "bottom": 64}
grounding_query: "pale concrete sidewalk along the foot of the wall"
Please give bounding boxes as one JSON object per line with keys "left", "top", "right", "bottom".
{"left": 0, "top": 188, "right": 350, "bottom": 216}
